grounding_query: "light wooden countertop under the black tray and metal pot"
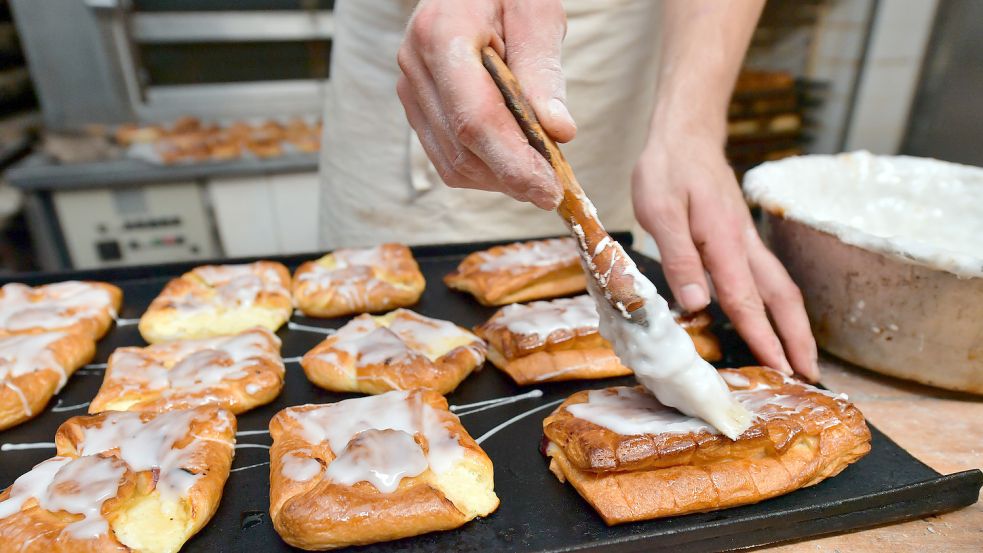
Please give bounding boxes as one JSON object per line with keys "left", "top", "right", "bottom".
{"left": 762, "top": 356, "right": 983, "bottom": 553}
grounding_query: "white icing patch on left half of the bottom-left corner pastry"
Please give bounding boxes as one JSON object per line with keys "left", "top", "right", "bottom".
{"left": 0, "top": 455, "right": 126, "bottom": 540}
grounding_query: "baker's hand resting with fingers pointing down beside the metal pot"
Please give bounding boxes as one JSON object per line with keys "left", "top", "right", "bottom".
{"left": 632, "top": 133, "right": 819, "bottom": 381}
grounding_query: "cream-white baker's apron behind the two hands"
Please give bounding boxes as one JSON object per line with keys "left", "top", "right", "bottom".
{"left": 320, "top": 0, "right": 661, "bottom": 249}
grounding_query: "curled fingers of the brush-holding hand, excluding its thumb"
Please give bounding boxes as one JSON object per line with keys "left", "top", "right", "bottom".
{"left": 398, "top": 1, "right": 562, "bottom": 209}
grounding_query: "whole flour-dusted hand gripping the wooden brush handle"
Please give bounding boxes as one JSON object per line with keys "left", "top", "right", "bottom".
{"left": 396, "top": 0, "right": 576, "bottom": 209}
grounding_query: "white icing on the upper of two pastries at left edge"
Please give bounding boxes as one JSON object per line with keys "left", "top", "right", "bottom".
{"left": 0, "top": 280, "right": 116, "bottom": 331}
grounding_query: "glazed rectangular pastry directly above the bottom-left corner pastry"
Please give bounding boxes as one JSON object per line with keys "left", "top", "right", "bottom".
{"left": 89, "top": 327, "right": 284, "bottom": 414}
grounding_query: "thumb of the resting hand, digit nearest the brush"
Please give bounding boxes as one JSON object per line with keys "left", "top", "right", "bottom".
{"left": 633, "top": 175, "right": 710, "bottom": 312}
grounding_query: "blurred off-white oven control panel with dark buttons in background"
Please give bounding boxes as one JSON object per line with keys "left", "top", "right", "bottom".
{"left": 52, "top": 182, "right": 219, "bottom": 269}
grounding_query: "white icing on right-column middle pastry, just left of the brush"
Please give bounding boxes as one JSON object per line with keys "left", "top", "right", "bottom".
{"left": 491, "top": 294, "right": 598, "bottom": 340}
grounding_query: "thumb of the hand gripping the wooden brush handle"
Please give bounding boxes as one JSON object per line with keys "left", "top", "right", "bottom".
{"left": 502, "top": 0, "right": 577, "bottom": 142}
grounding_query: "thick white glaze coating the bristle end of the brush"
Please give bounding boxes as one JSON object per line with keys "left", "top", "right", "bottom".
{"left": 571, "top": 207, "right": 751, "bottom": 439}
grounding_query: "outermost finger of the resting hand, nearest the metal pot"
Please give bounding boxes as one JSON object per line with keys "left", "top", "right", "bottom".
{"left": 748, "top": 228, "right": 819, "bottom": 382}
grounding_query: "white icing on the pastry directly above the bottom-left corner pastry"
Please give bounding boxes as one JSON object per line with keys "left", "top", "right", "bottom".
{"left": 107, "top": 329, "right": 282, "bottom": 397}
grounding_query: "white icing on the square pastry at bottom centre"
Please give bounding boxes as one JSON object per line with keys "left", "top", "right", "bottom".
{"left": 285, "top": 391, "right": 464, "bottom": 493}
